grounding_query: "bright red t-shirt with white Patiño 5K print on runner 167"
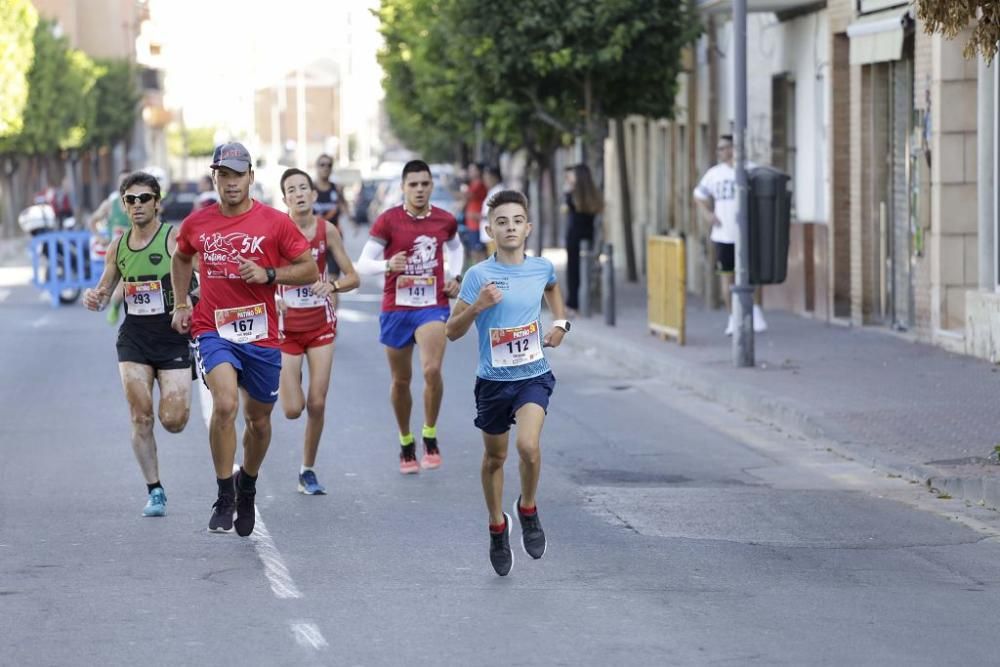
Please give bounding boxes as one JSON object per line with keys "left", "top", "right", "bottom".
{"left": 177, "top": 201, "right": 309, "bottom": 347}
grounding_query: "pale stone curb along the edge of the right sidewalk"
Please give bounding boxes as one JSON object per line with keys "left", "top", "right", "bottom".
{"left": 566, "top": 321, "right": 1000, "bottom": 510}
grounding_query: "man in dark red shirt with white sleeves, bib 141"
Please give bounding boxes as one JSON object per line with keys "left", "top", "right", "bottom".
{"left": 358, "top": 160, "right": 465, "bottom": 474}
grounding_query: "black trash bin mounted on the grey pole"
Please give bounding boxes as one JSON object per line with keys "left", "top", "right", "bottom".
{"left": 747, "top": 167, "right": 792, "bottom": 285}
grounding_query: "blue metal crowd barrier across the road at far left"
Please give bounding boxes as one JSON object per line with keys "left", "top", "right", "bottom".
{"left": 31, "top": 231, "right": 104, "bottom": 308}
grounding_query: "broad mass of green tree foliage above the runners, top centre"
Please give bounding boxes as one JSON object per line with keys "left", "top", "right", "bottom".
{"left": 379, "top": 0, "right": 699, "bottom": 162}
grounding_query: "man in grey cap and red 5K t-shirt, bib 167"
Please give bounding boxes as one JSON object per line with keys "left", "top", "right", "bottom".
{"left": 170, "top": 143, "right": 319, "bottom": 537}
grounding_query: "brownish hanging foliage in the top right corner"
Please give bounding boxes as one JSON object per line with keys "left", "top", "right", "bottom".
{"left": 917, "top": 0, "right": 1000, "bottom": 62}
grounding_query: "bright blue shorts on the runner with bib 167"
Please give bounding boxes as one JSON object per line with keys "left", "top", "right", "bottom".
{"left": 192, "top": 333, "right": 281, "bottom": 403}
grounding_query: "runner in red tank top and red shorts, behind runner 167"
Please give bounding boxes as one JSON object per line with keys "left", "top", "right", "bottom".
{"left": 278, "top": 169, "right": 361, "bottom": 496}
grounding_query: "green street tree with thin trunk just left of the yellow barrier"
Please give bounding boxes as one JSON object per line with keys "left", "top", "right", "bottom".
{"left": 452, "top": 0, "right": 700, "bottom": 280}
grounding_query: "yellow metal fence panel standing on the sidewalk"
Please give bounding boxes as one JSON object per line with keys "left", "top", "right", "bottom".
{"left": 646, "top": 236, "right": 687, "bottom": 345}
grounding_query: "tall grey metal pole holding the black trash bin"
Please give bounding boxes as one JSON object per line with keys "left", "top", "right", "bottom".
{"left": 733, "top": 0, "right": 754, "bottom": 368}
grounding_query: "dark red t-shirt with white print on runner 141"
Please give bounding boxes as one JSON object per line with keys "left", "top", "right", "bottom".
{"left": 371, "top": 206, "right": 458, "bottom": 311}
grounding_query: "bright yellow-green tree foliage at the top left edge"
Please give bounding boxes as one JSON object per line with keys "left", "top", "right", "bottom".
{"left": 0, "top": 0, "right": 38, "bottom": 141}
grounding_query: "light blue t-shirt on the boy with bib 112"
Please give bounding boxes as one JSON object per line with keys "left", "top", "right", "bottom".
{"left": 458, "top": 256, "right": 556, "bottom": 380}
